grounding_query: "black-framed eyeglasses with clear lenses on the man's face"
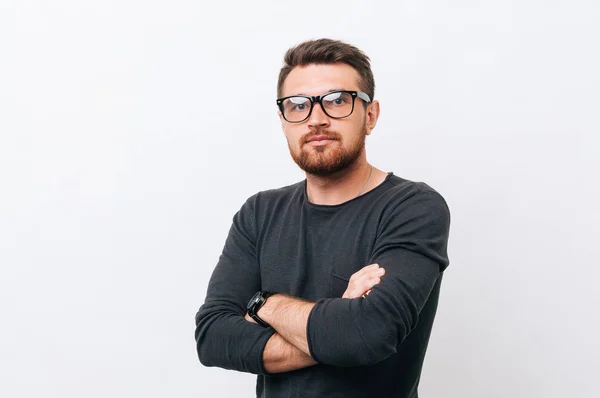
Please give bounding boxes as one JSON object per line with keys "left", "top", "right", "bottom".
{"left": 277, "top": 90, "right": 371, "bottom": 123}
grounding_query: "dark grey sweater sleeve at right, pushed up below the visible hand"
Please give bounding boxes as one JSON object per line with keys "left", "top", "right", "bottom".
{"left": 306, "top": 190, "right": 450, "bottom": 366}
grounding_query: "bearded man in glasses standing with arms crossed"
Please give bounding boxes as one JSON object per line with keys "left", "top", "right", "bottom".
{"left": 195, "top": 39, "right": 450, "bottom": 398}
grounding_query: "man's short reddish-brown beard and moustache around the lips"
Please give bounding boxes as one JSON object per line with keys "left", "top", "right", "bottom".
{"left": 288, "top": 120, "right": 367, "bottom": 177}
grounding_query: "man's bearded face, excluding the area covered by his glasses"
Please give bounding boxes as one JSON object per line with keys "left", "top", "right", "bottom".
{"left": 279, "top": 64, "right": 376, "bottom": 176}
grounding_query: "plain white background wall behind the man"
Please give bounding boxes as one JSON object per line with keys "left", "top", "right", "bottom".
{"left": 0, "top": 0, "right": 600, "bottom": 398}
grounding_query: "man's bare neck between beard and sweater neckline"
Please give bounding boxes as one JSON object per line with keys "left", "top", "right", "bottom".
{"left": 306, "top": 159, "right": 377, "bottom": 205}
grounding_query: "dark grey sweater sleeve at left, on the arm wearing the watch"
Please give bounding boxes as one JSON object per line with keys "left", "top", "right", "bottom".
{"left": 195, "top": 197, "right": 275, "bottom": 374}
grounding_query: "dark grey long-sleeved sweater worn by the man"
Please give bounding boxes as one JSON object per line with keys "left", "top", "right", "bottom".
{"left": 195, "top": 173, "right": 450, "bottom": 398}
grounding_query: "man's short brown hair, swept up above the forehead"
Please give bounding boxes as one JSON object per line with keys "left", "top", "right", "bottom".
{"left": 277, "top": 39, "right": 375, "bottom": 101}
